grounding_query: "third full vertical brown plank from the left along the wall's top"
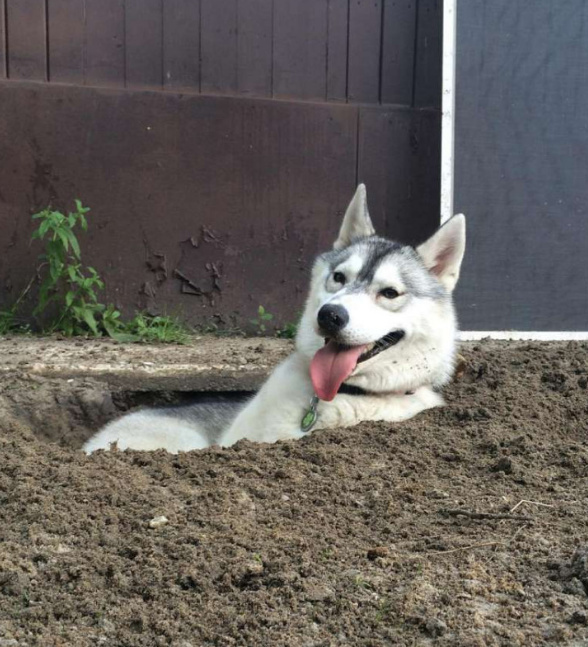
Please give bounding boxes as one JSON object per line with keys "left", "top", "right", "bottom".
{"left": 85, "top": 0, "right": 125, "bottom": 87}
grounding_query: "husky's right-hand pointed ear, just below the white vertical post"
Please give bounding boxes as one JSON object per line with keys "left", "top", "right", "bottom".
{"left": 417, "top": 213, "right": 465, "bottom": 292}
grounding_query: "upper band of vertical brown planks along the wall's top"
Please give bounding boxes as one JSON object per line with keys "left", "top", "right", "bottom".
{"left": 0, "top": 0, "right": 441, "bottom": 107}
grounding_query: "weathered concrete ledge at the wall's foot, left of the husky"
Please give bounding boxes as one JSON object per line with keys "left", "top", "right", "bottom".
{"left": 0, "top": 336, "right": 293, "bottom": 391}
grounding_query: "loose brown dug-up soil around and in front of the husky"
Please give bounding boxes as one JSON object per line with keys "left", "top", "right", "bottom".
{"left": 0, "top": 343, "right": 588, "bottom": 647}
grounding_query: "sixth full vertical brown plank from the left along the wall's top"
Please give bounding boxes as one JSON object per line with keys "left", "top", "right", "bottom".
{"left": 200, "top": 0, "right": 238, "bottom": 93}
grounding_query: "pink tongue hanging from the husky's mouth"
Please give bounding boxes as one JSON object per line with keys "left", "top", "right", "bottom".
{"left": 310, "top": 341, "right": 365, "bottom": 402}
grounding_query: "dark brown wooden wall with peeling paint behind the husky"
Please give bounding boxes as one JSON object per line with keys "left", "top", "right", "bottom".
{"left": 0, "top": 0, "right": 441, "bottom": 326}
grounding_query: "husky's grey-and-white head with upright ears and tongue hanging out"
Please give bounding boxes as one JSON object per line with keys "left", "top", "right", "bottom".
{"left": 297, "top": 184, "right": 465, "bottom": 400}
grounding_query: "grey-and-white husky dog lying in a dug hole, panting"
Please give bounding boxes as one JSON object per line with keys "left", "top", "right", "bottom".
{"left": 84, "top": 184, "right": 465, "bottom": 453}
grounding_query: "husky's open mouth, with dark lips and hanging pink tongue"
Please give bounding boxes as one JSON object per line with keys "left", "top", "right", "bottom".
{"left": 310, "top": 330, "right": 404, "bottom": 402}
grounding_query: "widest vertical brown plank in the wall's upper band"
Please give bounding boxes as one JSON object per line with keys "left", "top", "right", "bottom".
{"left": 273, "top": 0, "right": 327, "bottom": 99}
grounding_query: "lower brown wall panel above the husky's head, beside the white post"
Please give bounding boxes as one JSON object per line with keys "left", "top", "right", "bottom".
{"left": 358, "top": 106, "right": 441, "bottom": 244}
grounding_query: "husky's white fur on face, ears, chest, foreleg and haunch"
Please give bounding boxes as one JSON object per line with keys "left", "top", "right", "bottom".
{"left": 84, "top": 185, "right": 465, "bottom": 453}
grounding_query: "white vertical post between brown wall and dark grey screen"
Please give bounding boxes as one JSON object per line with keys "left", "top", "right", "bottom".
{"left": 441, "top": 0, "right": 457, "bottom": 224}
